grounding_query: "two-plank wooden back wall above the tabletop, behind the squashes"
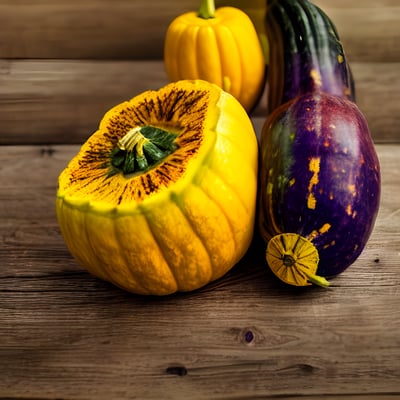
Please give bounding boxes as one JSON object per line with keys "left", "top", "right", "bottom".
{"left": 0, "top": 0, "right": 400, "bottom": 144}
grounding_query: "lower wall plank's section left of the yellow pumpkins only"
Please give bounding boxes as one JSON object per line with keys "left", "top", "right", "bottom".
{"left": 0, "top": 60, "right": 167, "bottom": 144}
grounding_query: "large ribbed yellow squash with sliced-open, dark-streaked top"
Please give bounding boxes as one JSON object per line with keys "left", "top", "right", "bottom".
{"left": 56, "top": 81, "right": 258, "bottom": 295}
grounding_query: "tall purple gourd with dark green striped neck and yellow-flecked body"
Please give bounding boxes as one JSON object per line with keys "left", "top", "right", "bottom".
{"left": 259, "top": 0, "right": 380, "bottom": 286}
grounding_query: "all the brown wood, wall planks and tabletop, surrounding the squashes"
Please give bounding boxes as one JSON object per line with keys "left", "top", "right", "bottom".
{"left": 0, "top": 0, "right": 400, "bottom": 400}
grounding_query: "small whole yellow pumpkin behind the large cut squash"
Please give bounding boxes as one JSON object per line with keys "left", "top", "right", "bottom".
{"left": 164, "top": 0, "right": 265, "bottom": 112}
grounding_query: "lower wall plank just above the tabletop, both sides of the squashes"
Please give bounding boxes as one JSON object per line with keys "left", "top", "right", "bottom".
{"left": 0, "top": 60, "right": 400, "bottom": 144}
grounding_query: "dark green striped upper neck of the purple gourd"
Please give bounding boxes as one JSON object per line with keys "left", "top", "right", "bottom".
{"left": 265, "top": 0, "right": 356, "bottom": 113}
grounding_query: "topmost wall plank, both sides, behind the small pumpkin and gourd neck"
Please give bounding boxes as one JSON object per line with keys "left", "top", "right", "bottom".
{"left": 0, "top": 0, "right": 400, "bottom": 62}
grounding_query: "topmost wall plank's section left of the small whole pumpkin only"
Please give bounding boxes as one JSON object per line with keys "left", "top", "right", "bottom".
{"left": 0, "top": 0, "right": 197, "bottom": 59}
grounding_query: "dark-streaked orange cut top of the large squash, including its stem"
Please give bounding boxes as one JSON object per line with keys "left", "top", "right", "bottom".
{"left": 58, "top": 81, "right": 221, "bottom": 206}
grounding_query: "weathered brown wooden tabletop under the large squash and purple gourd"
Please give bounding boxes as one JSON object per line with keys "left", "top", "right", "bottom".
{"left": 0, "top": 144, "right": 400, "bottom": 400}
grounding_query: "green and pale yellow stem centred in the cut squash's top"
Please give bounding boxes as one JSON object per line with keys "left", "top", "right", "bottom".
{"left": 109, "top": 126, "right": 178, "bottom": 176}
